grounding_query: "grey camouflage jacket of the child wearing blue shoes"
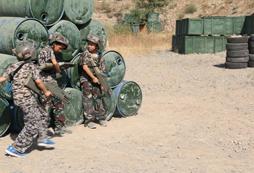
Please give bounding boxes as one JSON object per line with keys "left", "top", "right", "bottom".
{"left": 3, "top": 61, "right": 40, "bottom": 106}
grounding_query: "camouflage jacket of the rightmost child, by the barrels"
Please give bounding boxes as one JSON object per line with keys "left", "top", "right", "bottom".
{"left": 79, "top": 50, "right": 106, "bottom": 83}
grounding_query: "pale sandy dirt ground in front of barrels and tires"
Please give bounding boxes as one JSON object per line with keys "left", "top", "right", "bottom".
{"left": 0, "top": 51, "right": 254, "bottom": 173}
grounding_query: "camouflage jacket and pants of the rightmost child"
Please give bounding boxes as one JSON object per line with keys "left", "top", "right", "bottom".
{"left": 79, "top": 50, "right": 106, "bottom": 125}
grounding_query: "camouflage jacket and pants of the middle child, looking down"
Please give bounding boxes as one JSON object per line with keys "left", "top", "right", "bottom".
{"left": 38, "top": 46, "right": 65, "bottom": 127}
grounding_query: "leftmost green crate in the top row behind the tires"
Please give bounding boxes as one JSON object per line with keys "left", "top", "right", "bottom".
{"left": 182, "top": 18, "right": 204, "bottom": 35}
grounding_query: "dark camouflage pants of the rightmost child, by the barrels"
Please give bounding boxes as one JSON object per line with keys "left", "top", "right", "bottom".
{"left": 81, "top": 81, "right": 105, "bottom": 125}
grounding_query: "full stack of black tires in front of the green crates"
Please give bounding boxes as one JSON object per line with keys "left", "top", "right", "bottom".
{"left": 225, "top": 36, "right": 249, "bottom": 69}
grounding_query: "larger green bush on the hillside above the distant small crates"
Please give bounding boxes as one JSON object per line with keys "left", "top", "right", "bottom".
{"left": 131, "top": 0, "right": 169, "bottom": 23}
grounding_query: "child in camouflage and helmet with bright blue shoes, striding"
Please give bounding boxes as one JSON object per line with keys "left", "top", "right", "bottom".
{"left": 0, "top": 41, "right": 55, "bottom": 157}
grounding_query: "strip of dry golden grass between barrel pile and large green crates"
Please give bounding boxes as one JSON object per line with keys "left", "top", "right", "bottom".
{"left": 108, "top": 33, "right": 173, "bottom": 56}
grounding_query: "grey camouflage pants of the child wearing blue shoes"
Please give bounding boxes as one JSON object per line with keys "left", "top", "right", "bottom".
{"left": 12, "top": 102, "right": 48, "bottom": 153}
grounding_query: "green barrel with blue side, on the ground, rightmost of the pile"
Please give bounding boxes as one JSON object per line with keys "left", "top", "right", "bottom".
{"left": 114, "top": 81, "right": 142, "bottom": 117}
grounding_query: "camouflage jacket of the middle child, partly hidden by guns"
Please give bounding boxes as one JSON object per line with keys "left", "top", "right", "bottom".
{"left": 38, "top": 45, "right": 57, "bottom": 83}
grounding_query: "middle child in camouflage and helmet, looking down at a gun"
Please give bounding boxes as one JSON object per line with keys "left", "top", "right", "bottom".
{"left": 38, "top": 34, "right": 72, "bottom": 136}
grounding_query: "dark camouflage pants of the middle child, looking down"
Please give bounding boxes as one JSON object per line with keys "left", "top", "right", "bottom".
{"left": 39, "top": 96, "right": 65, "bottom": 127}
